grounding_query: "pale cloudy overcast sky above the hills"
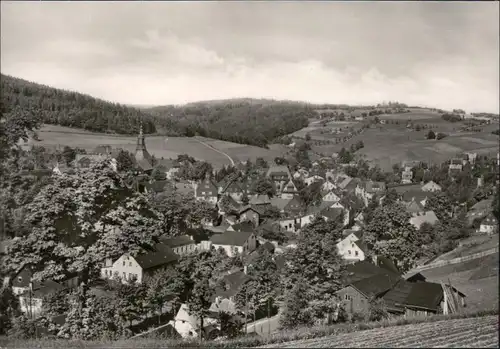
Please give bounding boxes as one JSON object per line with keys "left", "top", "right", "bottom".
{"left": 1, "top": 1, "right": 499, "bottom": 113}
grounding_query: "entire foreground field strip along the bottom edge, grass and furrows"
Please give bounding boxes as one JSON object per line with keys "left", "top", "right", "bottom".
{"left": 0, "top": 309, "right": 498, "bottom": 349}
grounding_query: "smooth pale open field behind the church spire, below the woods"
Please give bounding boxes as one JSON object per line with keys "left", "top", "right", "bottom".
{"left": 35, "top": 125, "right": 284, "bottom": 168}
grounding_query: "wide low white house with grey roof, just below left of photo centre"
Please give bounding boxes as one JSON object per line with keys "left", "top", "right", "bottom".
{"left": 210, "top": 229, "right": 257, "bottom": 257}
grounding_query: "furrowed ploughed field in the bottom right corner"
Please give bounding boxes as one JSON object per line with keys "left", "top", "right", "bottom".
{"left": 264, "top": 316, "right": 498, "bottom": 348}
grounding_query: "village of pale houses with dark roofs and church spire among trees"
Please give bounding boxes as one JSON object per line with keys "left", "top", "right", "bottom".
{"left": 2, "top": 127, "right": 500, "bottom": 339}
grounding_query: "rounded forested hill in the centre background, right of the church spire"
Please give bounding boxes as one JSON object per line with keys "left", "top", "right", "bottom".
{"left": 148, "top": 98, "right": 317, "bottom": 147}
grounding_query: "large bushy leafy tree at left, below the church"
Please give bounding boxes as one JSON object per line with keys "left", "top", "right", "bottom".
{"left": 4, "top": 161, "right": 160, "bottom": 284}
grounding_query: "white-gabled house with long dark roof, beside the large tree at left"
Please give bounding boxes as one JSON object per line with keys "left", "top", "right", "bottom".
{"left": 101, "top": 243, "right": 179, "bottom": 283}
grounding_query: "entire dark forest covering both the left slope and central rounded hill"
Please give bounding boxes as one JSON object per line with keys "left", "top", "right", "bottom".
{"left": 1, "top": 74, "right": 316, "bottom": 147}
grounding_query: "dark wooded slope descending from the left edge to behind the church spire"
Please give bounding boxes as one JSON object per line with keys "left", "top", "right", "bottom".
{"left": 1, "top": 74, "right": 183, "bottom": 135}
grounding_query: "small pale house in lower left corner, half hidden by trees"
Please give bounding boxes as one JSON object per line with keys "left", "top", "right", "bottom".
{"left": 19, "top": 280, "right": 65, "bottom": 318}
